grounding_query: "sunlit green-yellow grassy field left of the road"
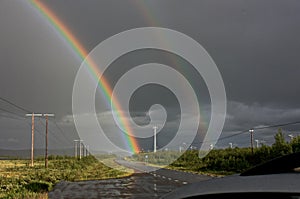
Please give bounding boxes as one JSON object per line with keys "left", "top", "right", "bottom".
{"left": 0, "top": 156, "right": 130, "bottom": 199}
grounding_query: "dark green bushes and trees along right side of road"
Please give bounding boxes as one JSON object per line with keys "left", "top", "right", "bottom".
{"left": 134, "top": 129, "right": 300, "bottom": 174}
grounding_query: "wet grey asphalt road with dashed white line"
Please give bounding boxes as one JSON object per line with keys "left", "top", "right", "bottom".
{"left": 49, "top": 160, "right": 211, "bottom": 199}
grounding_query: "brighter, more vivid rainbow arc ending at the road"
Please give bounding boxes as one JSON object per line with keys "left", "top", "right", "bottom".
{"left": 30, "top": 0, "right": 140, "bottom": 153}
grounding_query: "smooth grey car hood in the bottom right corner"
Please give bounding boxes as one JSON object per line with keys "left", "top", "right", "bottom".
{"left": 162, "top": 173, "right": 300, "bottom": 199}
